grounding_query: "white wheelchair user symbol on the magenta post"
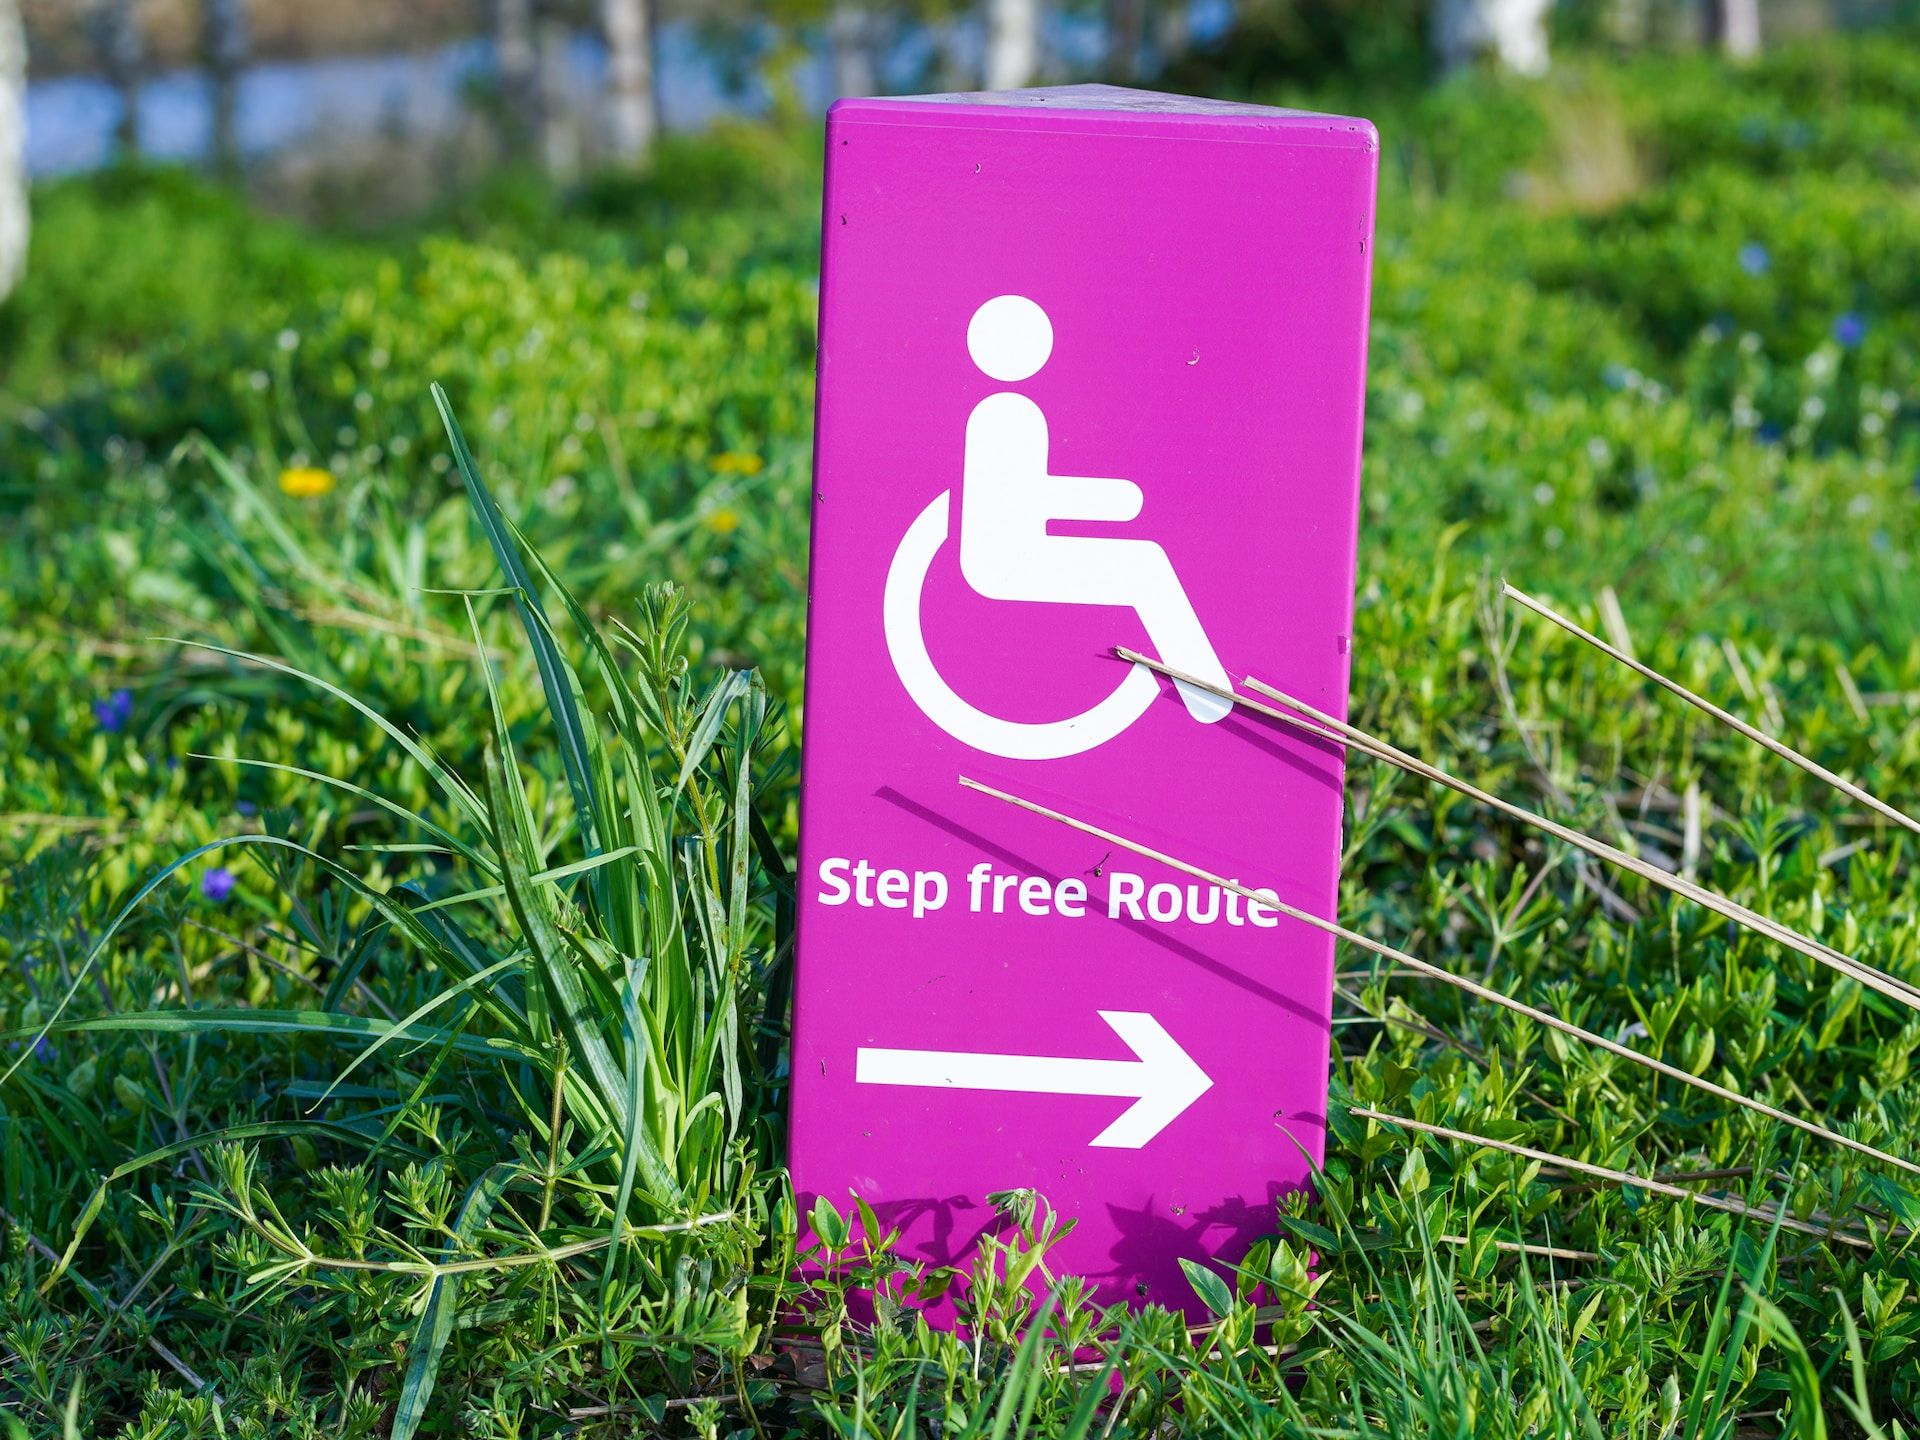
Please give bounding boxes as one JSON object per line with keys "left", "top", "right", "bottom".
{"left": 881, "top": 296, "right": 1233, "bottom": 760}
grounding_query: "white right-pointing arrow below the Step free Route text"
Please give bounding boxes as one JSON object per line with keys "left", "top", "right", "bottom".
{"left": 852, "top": 1010, "right": 1213, "bottom": 1150}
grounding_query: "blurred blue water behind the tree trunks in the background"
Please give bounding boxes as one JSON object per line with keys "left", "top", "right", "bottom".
{"left": 27, "top": 0, "right": 1233, "bottom": 175}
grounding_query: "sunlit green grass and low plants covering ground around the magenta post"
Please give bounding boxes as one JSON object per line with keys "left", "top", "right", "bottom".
{"left": 0, "top": 35, "right": 1920, "bottom": 1436}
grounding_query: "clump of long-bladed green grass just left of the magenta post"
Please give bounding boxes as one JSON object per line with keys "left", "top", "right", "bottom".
{"left": 15, "top": 399, "right": 791, "bottom": 1434}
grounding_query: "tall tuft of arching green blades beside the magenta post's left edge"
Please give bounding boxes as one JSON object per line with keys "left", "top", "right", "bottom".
{"left": 8, "top": 388, "right": 793, "bottom": 1436}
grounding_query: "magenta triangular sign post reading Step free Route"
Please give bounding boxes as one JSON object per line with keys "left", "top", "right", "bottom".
{"left": 791, "top": 86, "right": 1377, "bottom": 1309}
